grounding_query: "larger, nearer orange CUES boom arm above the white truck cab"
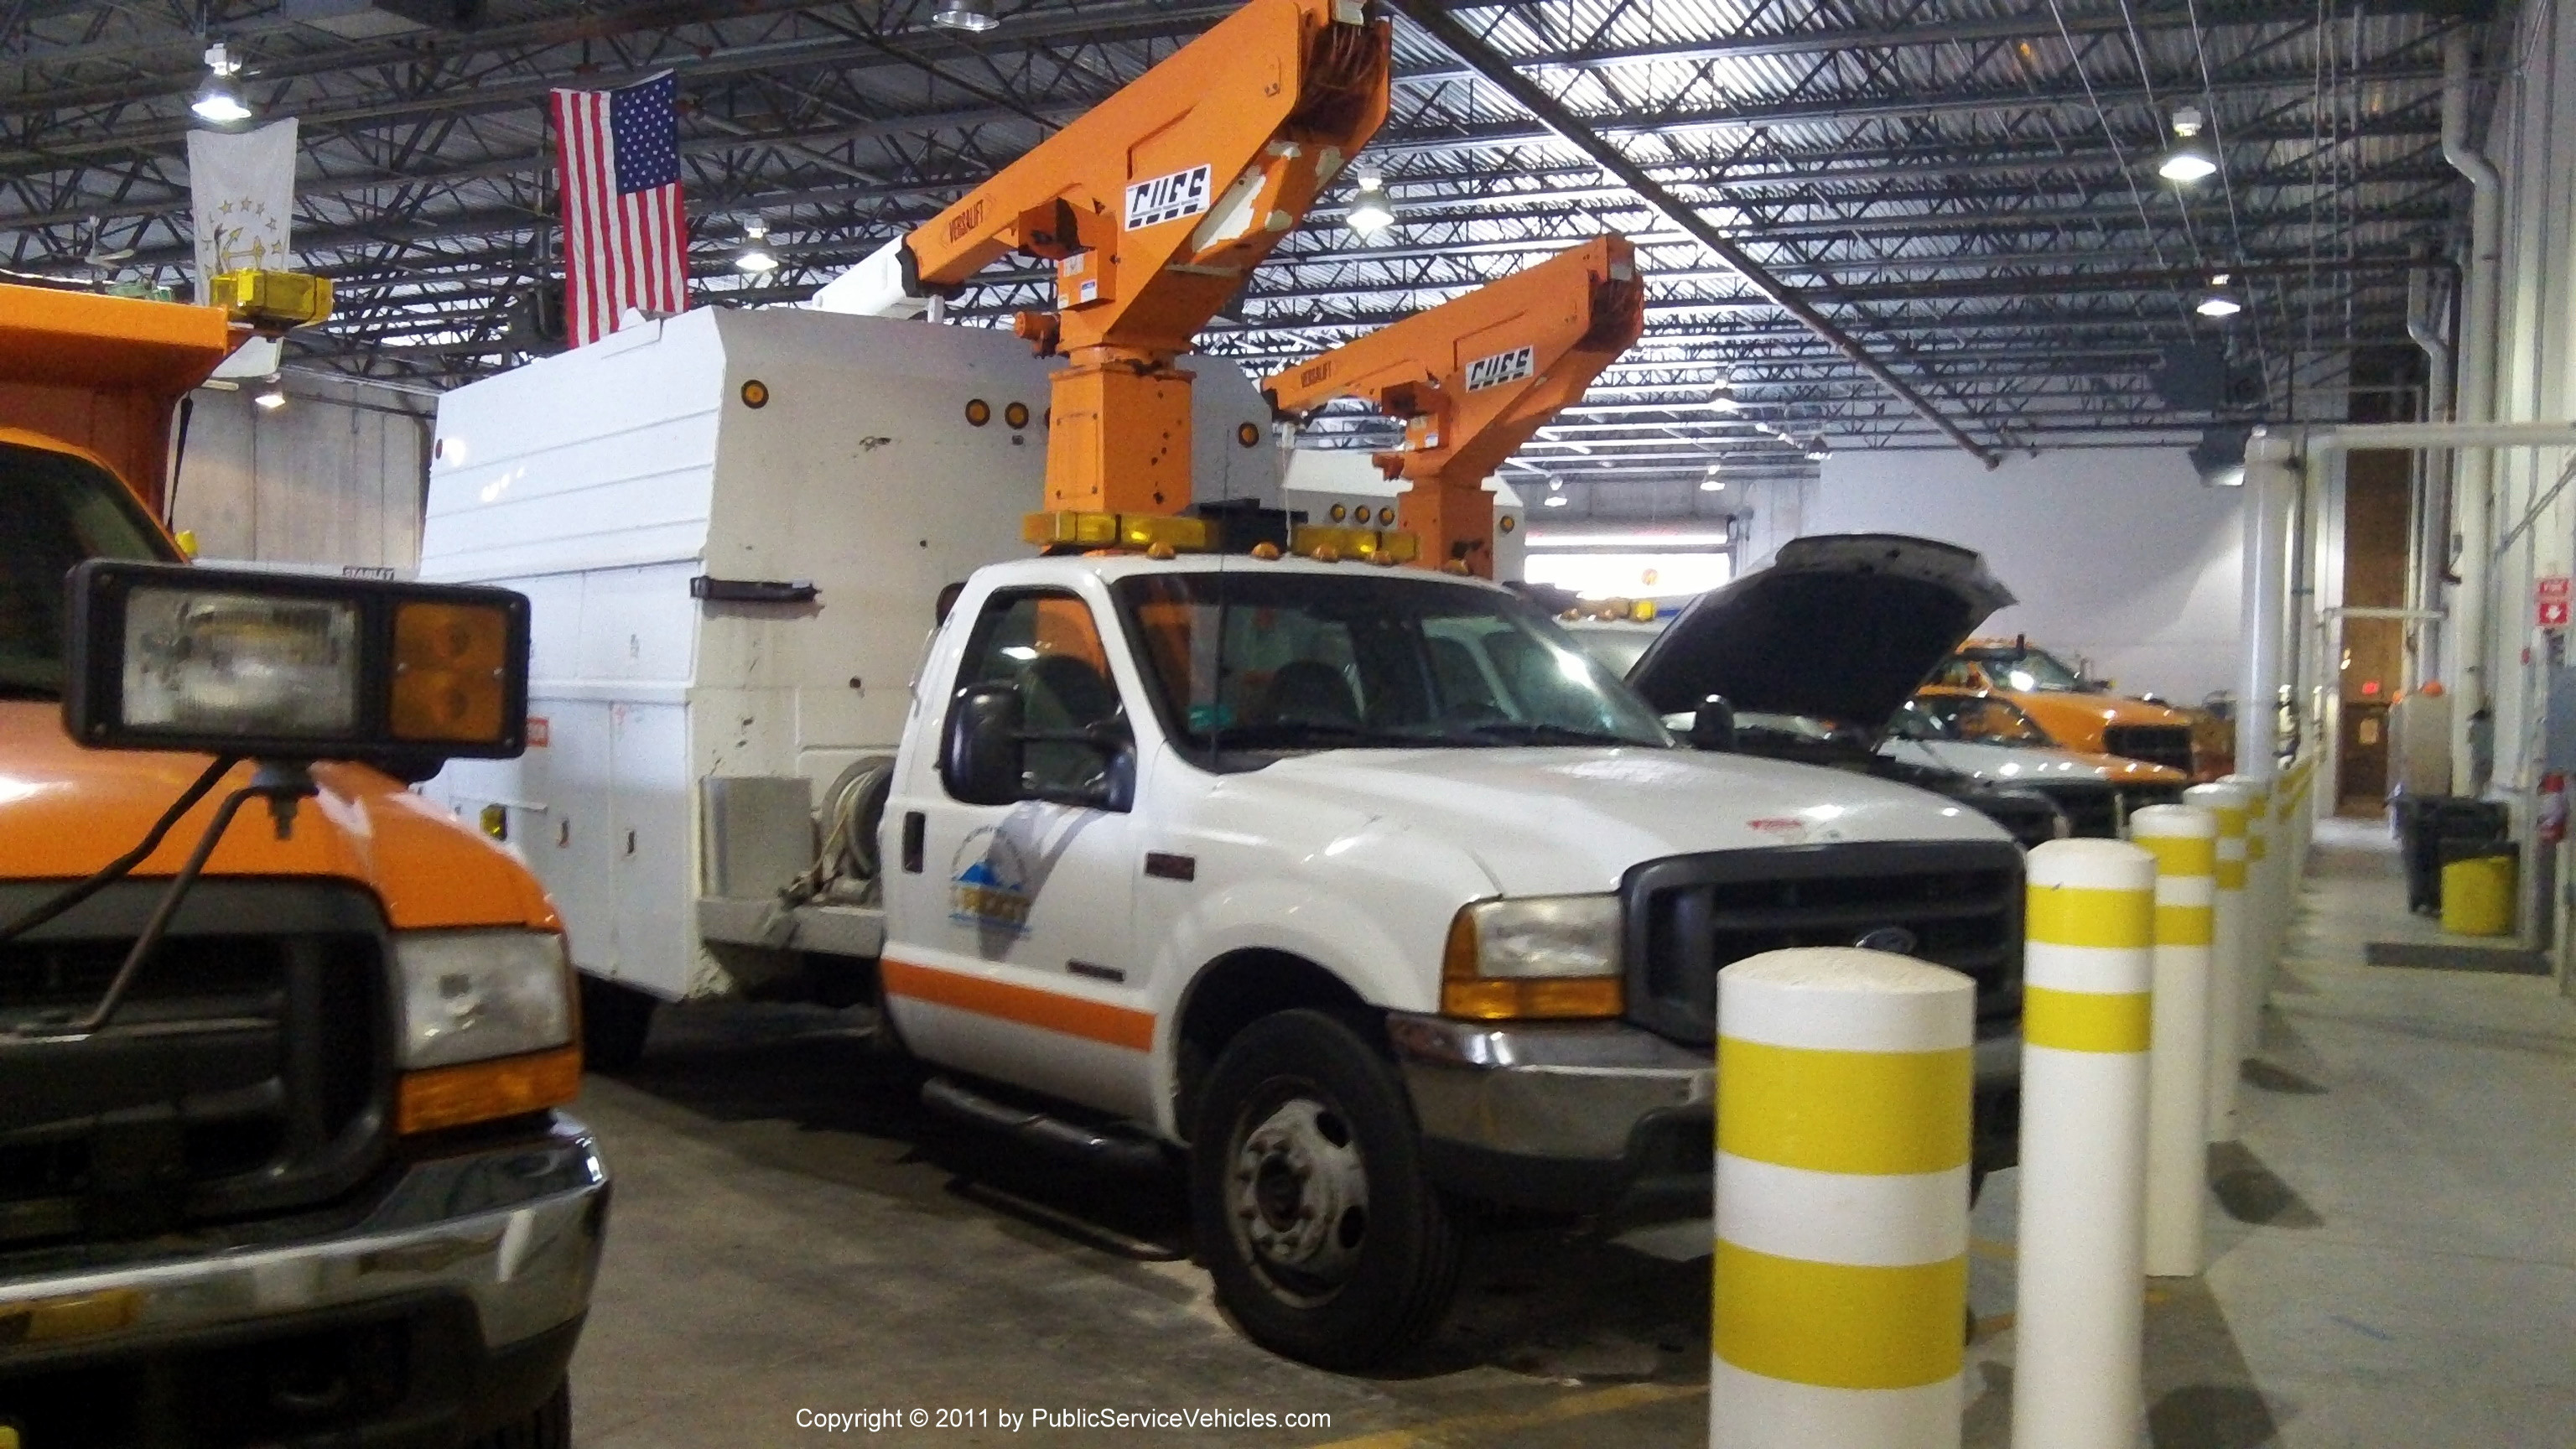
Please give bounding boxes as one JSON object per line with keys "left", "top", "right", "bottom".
{"left": 817, "top": 0, "right": 1391, "bottom": 516}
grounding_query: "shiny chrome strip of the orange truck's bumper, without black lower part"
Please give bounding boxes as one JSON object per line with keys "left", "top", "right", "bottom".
{"left": 0, "top": 1116, "right": 608, "bottom": 1367}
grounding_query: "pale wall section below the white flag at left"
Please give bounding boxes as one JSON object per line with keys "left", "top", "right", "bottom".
{"left": 173, "top": 374, "right": 435, "bottom": 573}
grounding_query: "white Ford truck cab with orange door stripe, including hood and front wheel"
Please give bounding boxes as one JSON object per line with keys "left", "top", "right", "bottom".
{"left": 879, "top": 546, "right": 2023, "bottom": 1364}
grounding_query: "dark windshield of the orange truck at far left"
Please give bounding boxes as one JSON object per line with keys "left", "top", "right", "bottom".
{"left": 0, "top": 444, "right": 163, "bottom": 699}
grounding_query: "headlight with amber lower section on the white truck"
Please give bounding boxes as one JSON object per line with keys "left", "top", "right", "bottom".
{"left": 1440, "top": 895, "right": 1625, "bottom": 1021}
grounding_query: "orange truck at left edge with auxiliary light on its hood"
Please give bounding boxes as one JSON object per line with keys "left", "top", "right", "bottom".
{"left": 0, "top": 273, "right": 608, "bottom": 1449}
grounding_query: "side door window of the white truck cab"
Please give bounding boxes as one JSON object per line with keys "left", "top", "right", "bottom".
{"left": 958, "top": 590, "right": 1125, "bottom": 792}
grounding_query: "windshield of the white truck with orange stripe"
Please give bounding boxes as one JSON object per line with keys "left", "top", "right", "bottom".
{"left": 1115, "top": 567, "right": 1672, "bottom": 753}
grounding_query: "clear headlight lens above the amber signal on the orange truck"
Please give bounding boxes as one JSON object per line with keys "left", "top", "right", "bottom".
{"left": 394, "top": 931, "right": 572, "bottom": 1070}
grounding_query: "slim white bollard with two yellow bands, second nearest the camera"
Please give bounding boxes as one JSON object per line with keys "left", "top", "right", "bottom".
{"left": 2009, "top": 840, "right": 2156, "bottom": 1449}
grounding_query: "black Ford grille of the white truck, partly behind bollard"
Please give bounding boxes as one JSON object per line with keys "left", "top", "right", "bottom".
{"left": 1620, "top": 840, "right": 2023, "bottom": 1044}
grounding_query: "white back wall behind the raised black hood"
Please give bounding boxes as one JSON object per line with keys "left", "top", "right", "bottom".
{"left": 1793, "top": 449, "right": 2241, "bottom": 704}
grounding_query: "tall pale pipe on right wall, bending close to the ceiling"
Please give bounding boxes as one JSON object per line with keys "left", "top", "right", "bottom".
{"left": 2442, "top": 29, "right": 2504, "bottom": 794}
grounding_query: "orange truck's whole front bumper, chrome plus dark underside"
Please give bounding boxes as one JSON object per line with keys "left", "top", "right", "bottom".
{"left": 0, "top": 1116, "right": 608, "bottom": 1449}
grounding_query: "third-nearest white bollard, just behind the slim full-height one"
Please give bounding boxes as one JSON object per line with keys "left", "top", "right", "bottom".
{"left": 2127, "top": 804, "right": 2218, "bottom": 1279}
